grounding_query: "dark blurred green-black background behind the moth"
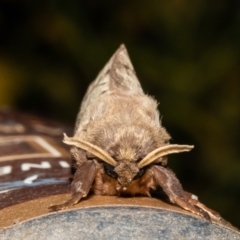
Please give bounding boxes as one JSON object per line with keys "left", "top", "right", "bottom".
{"left": 0, "top": 0, "right": 240, "bottom": 227}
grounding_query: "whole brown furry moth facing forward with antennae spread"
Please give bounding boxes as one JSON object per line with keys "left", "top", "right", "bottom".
{"left": 50, "top": 45, "right": 220, "bottom": 220}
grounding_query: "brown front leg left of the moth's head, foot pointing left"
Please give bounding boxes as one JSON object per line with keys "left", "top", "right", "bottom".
{"left": 49, "top": 161, "right": 96, "bottom": 211}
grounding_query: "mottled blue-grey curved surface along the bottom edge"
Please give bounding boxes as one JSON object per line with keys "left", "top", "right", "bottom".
{"left": 0, "top": 206, "right": 240, "bottom": 240}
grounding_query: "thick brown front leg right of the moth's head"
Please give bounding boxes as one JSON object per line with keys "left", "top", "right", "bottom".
{"left": 151, "top": 165, "right": 210, "bottom": 219}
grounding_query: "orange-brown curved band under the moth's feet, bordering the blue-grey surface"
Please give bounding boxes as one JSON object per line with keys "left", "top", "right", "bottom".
{"left": 0, "top": 194, "right": 237, "bottom": 231}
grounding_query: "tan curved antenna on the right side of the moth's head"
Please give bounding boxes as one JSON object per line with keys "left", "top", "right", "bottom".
{"left": 138, "top": 144, "right": 194, "bottom": 168}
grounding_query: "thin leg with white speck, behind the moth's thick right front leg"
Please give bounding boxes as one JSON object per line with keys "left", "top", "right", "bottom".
{"left": 184, "top": 191, "right": 222, "bottom": 221}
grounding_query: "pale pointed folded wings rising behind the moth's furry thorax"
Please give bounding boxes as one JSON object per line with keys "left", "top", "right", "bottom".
{"left": 75, "top": 44, "right": 144, "bottom": 132}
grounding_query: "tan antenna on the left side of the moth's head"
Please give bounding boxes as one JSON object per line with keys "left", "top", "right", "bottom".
{"left": 63, "top": 133, "right": 117, "bottom": 167}
